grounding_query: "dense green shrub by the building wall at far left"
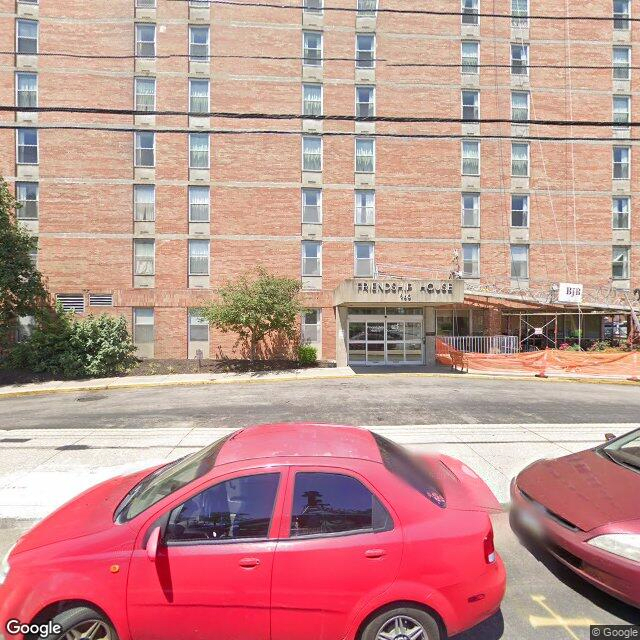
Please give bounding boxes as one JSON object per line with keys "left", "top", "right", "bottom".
{"left": 8, "top": 309, "right": 136, "bottom": 378}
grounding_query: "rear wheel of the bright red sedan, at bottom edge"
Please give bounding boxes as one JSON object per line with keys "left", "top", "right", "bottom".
{"left": 360, "top": 607, "right": 440, "bottom": 640}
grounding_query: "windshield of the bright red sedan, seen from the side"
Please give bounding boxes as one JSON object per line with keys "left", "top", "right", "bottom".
{"left": 114, "top": 435, "right": 231, "bottom": 523}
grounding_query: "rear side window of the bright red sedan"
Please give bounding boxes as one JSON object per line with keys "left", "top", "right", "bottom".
{"left": 290, "top": 473, "right": 393, "bottom": 538}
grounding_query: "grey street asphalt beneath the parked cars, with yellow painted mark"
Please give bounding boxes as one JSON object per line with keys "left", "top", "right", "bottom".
{"left": 0, "top": 513, "right": 640, "bottom": 640}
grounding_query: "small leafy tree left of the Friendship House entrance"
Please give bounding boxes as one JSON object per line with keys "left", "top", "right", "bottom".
{"left": 202, "top": 268, "right": 304, "bottom": 360}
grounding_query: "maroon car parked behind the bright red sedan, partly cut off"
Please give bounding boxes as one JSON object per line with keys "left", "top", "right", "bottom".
{"left": 511, "top": 429, "right": 640, "bottom": 608}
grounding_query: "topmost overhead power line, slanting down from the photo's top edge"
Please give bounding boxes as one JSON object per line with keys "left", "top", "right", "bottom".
{"left": 168, "top": 0, "right": 640, "bottom": 22}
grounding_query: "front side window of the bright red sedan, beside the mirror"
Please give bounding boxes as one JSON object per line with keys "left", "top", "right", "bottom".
{"left": 165, "top": 473, "right": 280, "bottom": 542}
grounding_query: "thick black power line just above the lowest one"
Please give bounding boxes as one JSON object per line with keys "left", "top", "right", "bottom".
{"left": 0, "top": 105, "right": 640, "bottom": 128}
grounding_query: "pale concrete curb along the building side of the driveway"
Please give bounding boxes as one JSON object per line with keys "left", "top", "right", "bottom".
{"left": 0, "top": 371, "right": 640, "bottom": 401}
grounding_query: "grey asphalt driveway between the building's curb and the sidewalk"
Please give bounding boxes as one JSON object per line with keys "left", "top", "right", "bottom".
{"left": 0, "top": 374, "right": 640, "bottom": 429}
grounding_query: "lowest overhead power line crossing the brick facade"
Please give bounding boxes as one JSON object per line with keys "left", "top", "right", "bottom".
{"left": 0, "top": 123, "right": 640, "bottom": 145}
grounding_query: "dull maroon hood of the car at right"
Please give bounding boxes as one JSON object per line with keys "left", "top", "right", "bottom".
{"left": 516, "top": 450, "right": 640, "bottom": 531}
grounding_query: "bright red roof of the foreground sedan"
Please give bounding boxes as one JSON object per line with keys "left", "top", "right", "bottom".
{"left": 216, "top": 423, "right": 382, "bottom": 465}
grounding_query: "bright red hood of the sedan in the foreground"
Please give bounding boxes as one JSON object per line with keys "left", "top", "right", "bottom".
{"left": 13, "top": 469, "right": 153, "bottom": 553}
